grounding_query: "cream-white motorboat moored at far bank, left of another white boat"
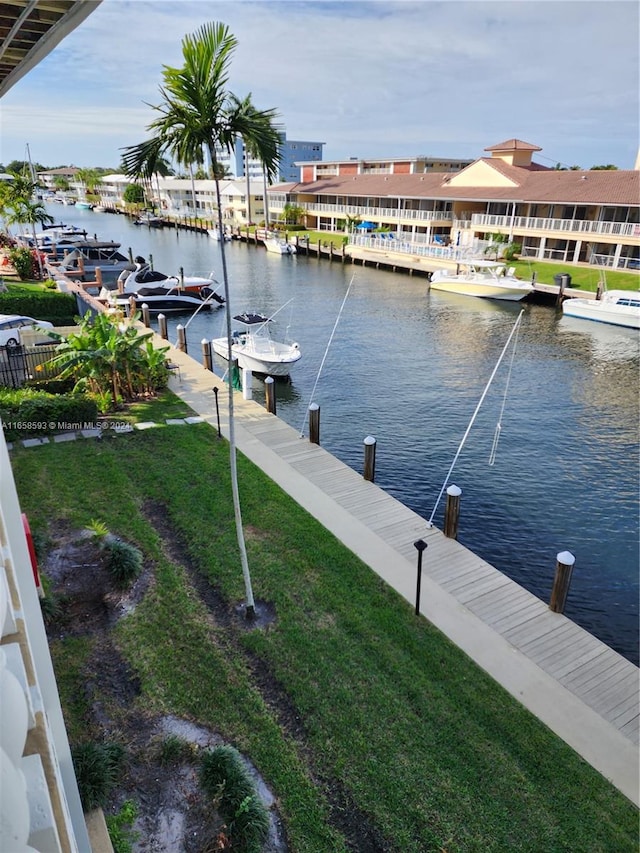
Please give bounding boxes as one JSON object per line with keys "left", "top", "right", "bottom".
{"left": 430, "top": 260, "right": 533, "bottom": 302}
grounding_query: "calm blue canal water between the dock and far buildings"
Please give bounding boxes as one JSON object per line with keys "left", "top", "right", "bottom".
{"left": 50, "top": 205, "right": 640, "bottom": 663}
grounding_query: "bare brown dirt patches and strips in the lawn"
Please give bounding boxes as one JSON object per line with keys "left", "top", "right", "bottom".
{"left": 41, "top": 505, "right": 391, "bottom": 853}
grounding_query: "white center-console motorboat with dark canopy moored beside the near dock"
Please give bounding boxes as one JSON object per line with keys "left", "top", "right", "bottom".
{"left": 211, "top": 313, "right": 302, "bottom": 378}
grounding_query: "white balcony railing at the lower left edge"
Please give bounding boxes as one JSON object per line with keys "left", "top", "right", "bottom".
{"left": 0, "top": 436, "right": 90, "bottom": 853}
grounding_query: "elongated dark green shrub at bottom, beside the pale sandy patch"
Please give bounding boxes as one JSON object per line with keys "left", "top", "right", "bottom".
{"left": 200, "top": 746, "right": 269, "bottom": 853}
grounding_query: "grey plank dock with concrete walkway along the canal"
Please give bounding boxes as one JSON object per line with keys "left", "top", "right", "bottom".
{"left": 162, "top": 341, "right": 640, "bottom": 804}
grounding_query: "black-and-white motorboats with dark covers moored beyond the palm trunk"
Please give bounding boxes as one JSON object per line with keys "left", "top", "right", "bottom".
{"left": 98, "top": 256, "right": 224, "bottom": 313}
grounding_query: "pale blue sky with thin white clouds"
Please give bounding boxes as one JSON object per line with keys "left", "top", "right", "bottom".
{"left": 0, "top": 0, "right": 640, "bottom": 169}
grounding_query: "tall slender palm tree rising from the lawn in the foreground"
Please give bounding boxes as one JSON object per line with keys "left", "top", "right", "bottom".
{"left": 123, "top": 22, "right": 280, "bottom": 618}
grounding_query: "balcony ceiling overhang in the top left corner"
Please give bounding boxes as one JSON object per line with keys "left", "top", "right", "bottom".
{"left": 0, "top": 0, "right": 102, "bottom": 98}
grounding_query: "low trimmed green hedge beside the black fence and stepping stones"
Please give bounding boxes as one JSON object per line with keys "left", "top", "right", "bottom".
{"left": 0, "top": 389, "right": 98, "bottom": 441}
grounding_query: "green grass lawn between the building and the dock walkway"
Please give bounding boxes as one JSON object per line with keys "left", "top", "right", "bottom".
{"left": 11, "top": 395, "right": 638, "bottom": 853}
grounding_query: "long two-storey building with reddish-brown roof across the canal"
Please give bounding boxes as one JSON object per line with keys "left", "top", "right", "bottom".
{"left": 268, "top": 139, "right": 640, "bottom": 269}
